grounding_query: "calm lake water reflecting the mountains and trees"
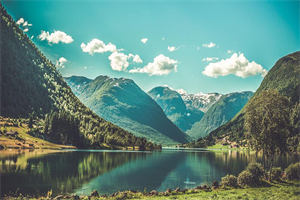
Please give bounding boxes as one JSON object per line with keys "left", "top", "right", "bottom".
{"left": 0, "top": 150, "right": 296, "bottom": 196}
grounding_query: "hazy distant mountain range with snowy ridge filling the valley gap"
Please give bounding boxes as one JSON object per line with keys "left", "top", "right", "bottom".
{"left": 148, "top": 86, "right": 253, "bottom": 139}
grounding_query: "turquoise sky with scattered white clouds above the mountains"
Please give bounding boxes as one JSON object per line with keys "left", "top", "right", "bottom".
{"left": 1, "top": 0, "right": 300, "bottom": 94}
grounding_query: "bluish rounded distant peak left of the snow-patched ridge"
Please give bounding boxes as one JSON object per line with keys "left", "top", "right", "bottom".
{"left": 148, "top": 86, "right": 203, "bottom": 131}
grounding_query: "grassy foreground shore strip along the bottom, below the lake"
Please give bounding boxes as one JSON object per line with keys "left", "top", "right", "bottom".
{"left": 4, "top": 181, "right": 300, "bottom": 200}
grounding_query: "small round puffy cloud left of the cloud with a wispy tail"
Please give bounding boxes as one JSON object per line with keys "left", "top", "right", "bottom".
{"left": 108, "top": 52, "right": 129, "bottom": 71}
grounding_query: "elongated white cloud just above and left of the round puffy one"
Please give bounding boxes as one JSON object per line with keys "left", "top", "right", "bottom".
{"left": 80, "top": 38, "right": 117, "bottom": 55}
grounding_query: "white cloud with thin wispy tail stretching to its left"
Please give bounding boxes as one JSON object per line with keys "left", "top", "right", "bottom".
{"left": 129, "top": 54, "right": 178, "bottom": 76}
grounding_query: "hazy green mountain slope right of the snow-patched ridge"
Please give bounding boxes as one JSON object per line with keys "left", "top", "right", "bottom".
{"left": 187, "top": 92, "right": 253, "bottom": 139}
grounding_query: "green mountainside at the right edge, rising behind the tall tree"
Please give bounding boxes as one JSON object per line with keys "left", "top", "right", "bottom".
{"left": 207, "top": 51, "right": 300, "bottom": 143}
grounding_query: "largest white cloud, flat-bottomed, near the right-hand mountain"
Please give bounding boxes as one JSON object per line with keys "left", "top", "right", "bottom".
{"left": 202, "top": 53, "right": 267, "bottom": 78}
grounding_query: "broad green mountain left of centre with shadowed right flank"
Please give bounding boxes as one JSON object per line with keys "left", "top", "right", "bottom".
{"left": 65, "top": 76, "right": 188, "bottom": 144}
